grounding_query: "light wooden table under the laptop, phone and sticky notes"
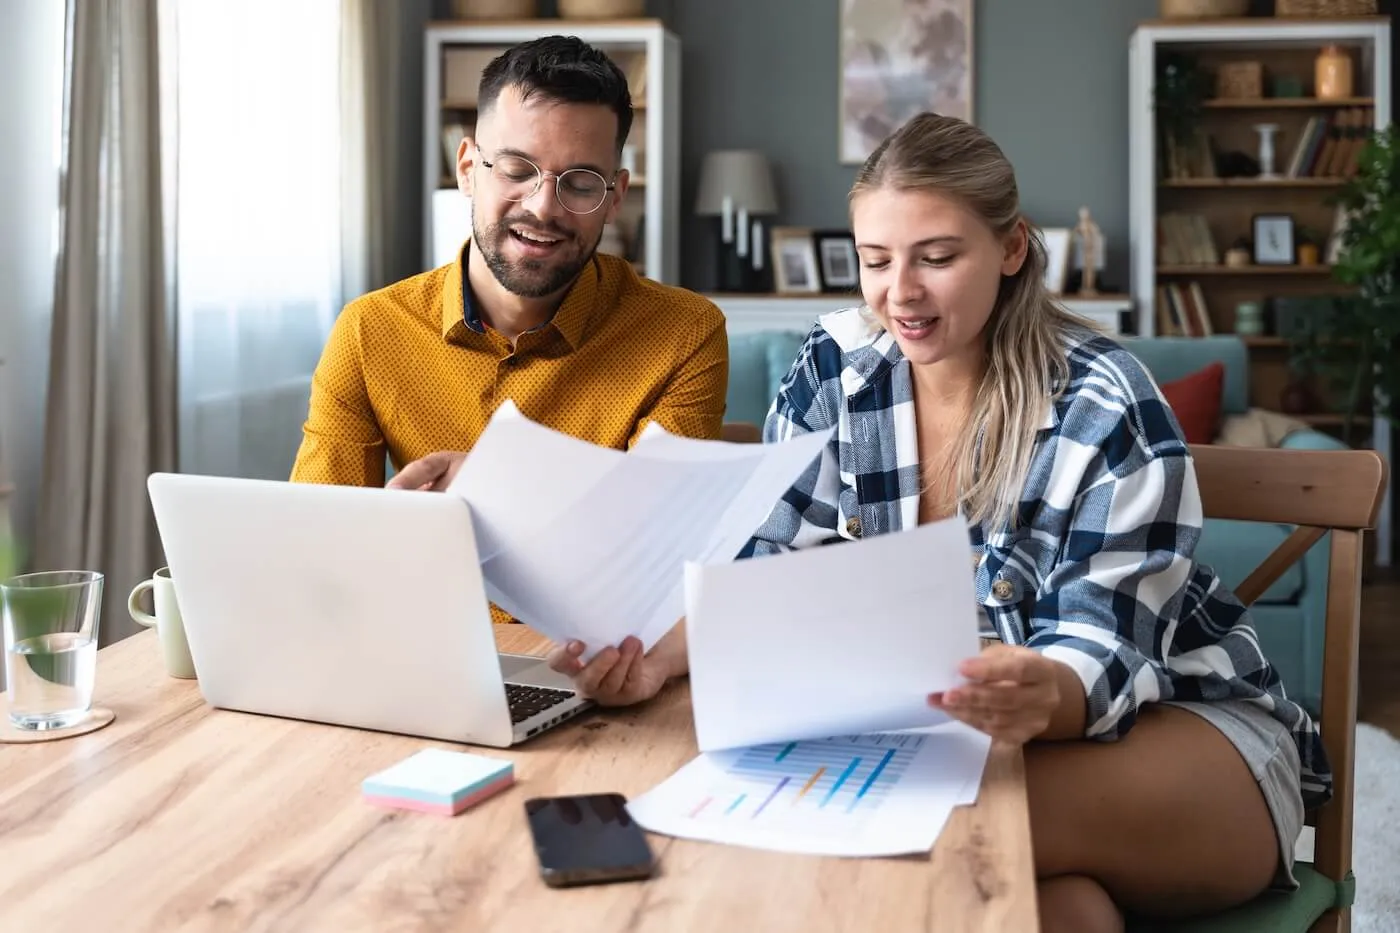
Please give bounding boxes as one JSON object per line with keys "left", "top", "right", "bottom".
{"left": 0, "top": 626, "right": 1036, "bottom": 933}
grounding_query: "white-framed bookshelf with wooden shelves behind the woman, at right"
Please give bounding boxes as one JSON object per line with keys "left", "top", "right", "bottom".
{"left": 1128, "top": 17, "right": 1392, "bottom": 565}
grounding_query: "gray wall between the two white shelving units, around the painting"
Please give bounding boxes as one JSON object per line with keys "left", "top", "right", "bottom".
{"left": 651, "top": 0, "right": 1158, "bottom": 290}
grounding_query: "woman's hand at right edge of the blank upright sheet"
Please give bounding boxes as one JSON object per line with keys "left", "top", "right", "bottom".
{"left": 928, "top": 644, "right": 1060, "bottom": 744}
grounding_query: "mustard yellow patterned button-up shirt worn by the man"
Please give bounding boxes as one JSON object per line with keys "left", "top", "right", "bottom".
{"left": 291, "top": 248, "right": 729, "bottom": 486}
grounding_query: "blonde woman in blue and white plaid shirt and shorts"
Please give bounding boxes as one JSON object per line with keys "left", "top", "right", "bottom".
{"left": 554, "top": 113, "right": 1331, "bottom": 932}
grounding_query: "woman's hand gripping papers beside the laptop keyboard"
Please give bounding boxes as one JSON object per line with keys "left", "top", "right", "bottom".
{"left": 547, "top": 619, "right": 689, "bottom": 706}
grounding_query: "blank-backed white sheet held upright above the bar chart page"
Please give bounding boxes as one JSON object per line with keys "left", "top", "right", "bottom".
{"left": 686, "top": 517, "right": 981, "bottom": 751}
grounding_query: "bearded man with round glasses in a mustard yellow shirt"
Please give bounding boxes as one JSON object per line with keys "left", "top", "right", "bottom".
{"left": 291, "top": 36, "right": 729, "bottom": 501}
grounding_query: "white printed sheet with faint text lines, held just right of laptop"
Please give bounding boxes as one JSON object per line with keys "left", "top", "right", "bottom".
{"left": 481, "top": 431, "right": 830, "bottom": 658}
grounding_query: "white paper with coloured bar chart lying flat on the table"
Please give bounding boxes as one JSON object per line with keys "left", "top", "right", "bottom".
{"left": 627, "top": 723, "right": 991, "bottom": 856}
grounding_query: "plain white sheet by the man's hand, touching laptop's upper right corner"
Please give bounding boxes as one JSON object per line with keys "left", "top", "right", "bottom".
{"left": 447, "top": 399, "right": 626, "bottom": 560}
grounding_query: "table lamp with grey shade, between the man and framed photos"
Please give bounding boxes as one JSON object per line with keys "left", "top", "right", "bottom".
{"left": 696, "top": 148, "right": 778, "bottom": 291}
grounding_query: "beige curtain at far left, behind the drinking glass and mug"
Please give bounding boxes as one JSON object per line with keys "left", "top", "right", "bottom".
{"left": 35, "top": 0, "right": 176, "bottom": 644}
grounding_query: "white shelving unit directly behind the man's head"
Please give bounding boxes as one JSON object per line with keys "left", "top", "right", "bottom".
{"left": 423, "top": 20, "right": 680, "bottom": 284}
